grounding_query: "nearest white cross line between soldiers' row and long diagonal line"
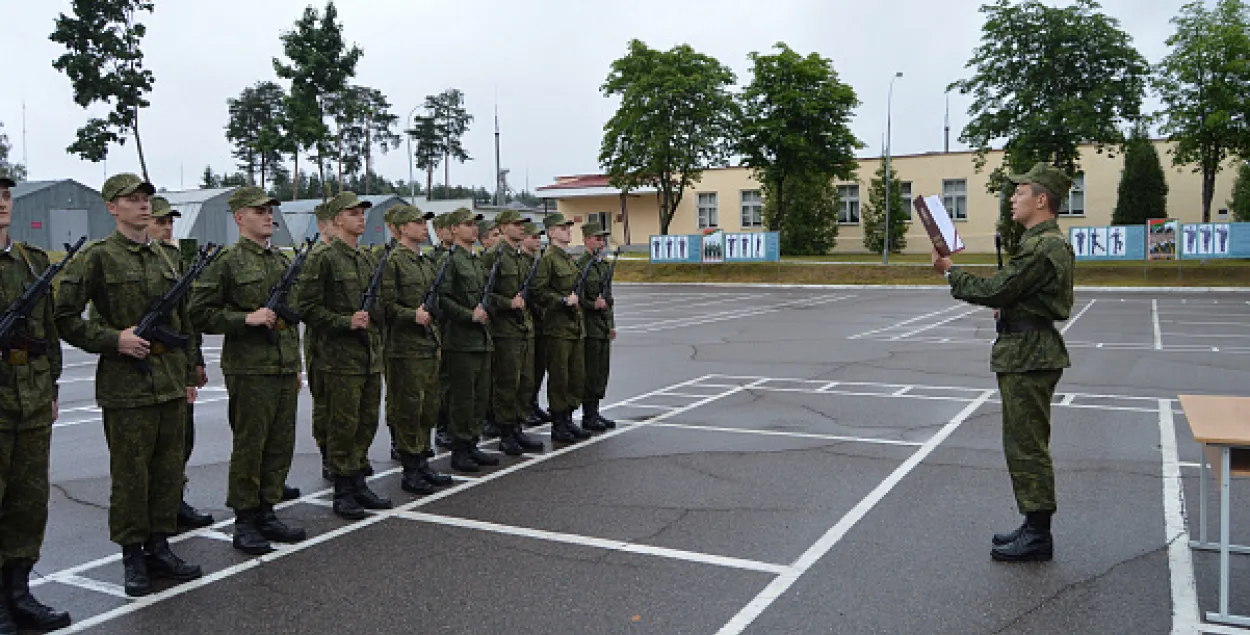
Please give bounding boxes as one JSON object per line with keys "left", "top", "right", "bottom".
{"left": 395, "top": 511, "right": 788, "bottom": 575}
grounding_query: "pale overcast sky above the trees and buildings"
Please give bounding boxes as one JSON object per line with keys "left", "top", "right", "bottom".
{"left": 0, "top": 0, "right": 1184, "bottom": 195}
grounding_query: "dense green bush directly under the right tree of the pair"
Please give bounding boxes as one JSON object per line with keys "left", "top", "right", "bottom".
{"left": 764, "top": 173, "right": 838, "bottom": 256}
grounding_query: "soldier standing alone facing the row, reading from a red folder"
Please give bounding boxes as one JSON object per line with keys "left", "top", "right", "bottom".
{"left": 933, "top": 164, "right": 1076, "bottom": 563}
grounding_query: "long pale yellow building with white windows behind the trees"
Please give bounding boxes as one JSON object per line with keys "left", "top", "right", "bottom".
{"left": 538, "top": 141, "right": 1236, "bottom": 253}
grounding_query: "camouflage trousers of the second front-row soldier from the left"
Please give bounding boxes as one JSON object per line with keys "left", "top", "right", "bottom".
{"left": 104, "top": 398, "right": 186, "bottom": 545}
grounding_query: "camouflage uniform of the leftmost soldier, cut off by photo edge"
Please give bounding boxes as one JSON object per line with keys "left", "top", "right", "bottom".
{"left": 0, "top": 241, "right": 61, "bottom": 566}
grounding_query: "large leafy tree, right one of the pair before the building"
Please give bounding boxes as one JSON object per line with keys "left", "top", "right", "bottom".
{"left": 738, "top": 43, "right": 864, "bottom": 231}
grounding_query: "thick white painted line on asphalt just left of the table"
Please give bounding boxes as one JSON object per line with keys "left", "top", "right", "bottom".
{"left": 1159, "top": 399, "right": 1201, "bottom": 635}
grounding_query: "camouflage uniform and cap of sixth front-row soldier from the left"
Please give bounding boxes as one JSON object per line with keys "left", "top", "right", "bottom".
{"left": 439, "top": 210, "right": 494, "bottom": 445}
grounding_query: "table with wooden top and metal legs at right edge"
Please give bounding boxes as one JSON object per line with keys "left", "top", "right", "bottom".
{"left": 1180, "top": 395, "right": 1250, "bottom": 626}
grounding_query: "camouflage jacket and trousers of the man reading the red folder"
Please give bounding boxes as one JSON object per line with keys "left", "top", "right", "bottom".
{"left": 949, "top": 173, "right": 1075, "bottom": 514}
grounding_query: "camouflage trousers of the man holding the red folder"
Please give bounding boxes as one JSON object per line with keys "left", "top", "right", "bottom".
{"left": 999, "top": 370, "right": 1064, "bottom": 514}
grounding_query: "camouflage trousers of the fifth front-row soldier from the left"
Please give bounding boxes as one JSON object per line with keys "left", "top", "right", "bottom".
{"left": 386, "top": 353, "right": 439, "bottom": 454}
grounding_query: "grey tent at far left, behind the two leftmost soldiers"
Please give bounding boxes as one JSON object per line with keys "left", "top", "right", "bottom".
{"left": 9, "top": 179, "right": 115, "bottom": 251}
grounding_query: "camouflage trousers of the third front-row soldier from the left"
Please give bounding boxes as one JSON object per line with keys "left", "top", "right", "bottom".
{"left": 226, "top": 373, "right": 300, "bottom": 510}
